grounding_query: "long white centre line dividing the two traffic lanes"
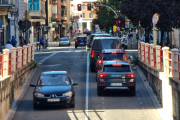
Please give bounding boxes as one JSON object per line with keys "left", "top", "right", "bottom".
{"left": 85, "top": 52, "right": 89, "bottom": 120}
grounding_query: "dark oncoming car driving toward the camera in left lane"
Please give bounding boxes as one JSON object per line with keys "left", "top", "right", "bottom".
{"left": 30, "top": 71, "right": 78, "bottom": 109}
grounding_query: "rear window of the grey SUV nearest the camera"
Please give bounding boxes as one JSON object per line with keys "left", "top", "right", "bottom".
{"left": 103, "top": 65, "right": 131, "bottom": 72}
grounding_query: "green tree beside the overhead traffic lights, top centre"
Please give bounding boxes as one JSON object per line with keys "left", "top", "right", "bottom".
{"left": 93, "top": 0, "right": 121, "bottom": 32}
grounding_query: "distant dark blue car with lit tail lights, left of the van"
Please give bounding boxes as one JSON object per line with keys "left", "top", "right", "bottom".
{"left": 75, "top": 36, "right": 87, "bottom": 48}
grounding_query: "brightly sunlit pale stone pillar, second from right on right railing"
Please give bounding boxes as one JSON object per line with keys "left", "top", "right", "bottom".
{"left": 162, "top": 47, "right": 169, "bottom": 75}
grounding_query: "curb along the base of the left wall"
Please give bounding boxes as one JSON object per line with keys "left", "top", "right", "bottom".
{"left": 4, "top": 67, "right": 38, "bottom": 120}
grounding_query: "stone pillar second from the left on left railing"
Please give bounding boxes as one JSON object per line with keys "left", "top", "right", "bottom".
{"left": 11, "top": 47, "right": 16, "bottom": 72}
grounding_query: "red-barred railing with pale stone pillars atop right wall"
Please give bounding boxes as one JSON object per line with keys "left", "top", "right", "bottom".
{"left": 138, "top": 41, "right": 180, "bottom": 80}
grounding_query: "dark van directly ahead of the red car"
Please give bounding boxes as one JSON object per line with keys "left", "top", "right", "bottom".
{"left": 90, "top": 37, "right": 121, "bottom": 72}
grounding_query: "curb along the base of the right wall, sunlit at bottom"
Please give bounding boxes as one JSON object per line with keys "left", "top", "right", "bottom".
{"left": 137, "top": 66, "right": 173, "bottom": 120}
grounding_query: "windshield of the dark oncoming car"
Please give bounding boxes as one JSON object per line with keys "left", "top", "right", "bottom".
{"left": 38, "top": 75, "right": 70, "bottom": 86}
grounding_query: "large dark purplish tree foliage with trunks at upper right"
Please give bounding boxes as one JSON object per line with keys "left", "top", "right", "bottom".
{"left": 121, "top": 0, "right": 180, "bottom": 46}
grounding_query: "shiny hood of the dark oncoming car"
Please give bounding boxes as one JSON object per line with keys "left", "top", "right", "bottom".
{"left": 35, "top": 85, "right": 71, "bottom": 94}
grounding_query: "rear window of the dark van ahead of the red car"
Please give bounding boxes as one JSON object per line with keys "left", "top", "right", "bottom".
{"left": 92, "top": 39, "right": 121, "bottom": 51}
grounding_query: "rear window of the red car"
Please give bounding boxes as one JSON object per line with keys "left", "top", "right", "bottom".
{"left": 102, "top": 53, "right": 126, "bottom": 61}
